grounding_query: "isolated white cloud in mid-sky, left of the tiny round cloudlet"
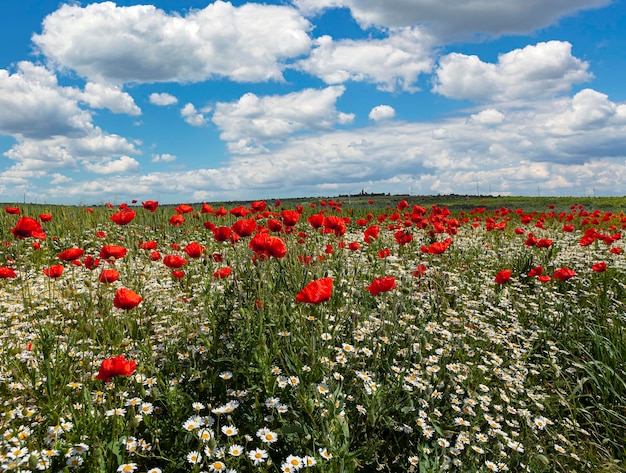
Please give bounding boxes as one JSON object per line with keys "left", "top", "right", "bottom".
{"left": 213, "top": 86, "right": 354, "bottom": 154}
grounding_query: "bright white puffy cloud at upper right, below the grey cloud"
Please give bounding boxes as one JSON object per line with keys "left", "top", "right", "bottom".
{"left": 433, "top": 41, "right": 592, "bottom": 102}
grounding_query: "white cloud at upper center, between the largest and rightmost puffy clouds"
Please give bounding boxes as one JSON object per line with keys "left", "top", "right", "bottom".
{"left": 296, "top": 28, "right": 433, "bottom": 92}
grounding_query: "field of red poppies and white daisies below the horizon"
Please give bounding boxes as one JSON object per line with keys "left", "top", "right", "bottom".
{"left": 0, "top": 199, "right": 626, "bottom": 473}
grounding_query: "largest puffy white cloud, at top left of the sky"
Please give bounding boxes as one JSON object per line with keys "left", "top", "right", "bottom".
{"left": 32, "top": 0, "right": 311, "bottom": 84}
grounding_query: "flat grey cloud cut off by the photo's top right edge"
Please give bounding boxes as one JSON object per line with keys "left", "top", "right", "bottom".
{"left": 292, "top": 0, "right": 610, "bottom": 42}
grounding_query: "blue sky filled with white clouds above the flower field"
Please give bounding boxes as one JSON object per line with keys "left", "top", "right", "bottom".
{"left": 0, "top": 0, "right": 626, "bottom": 204}
